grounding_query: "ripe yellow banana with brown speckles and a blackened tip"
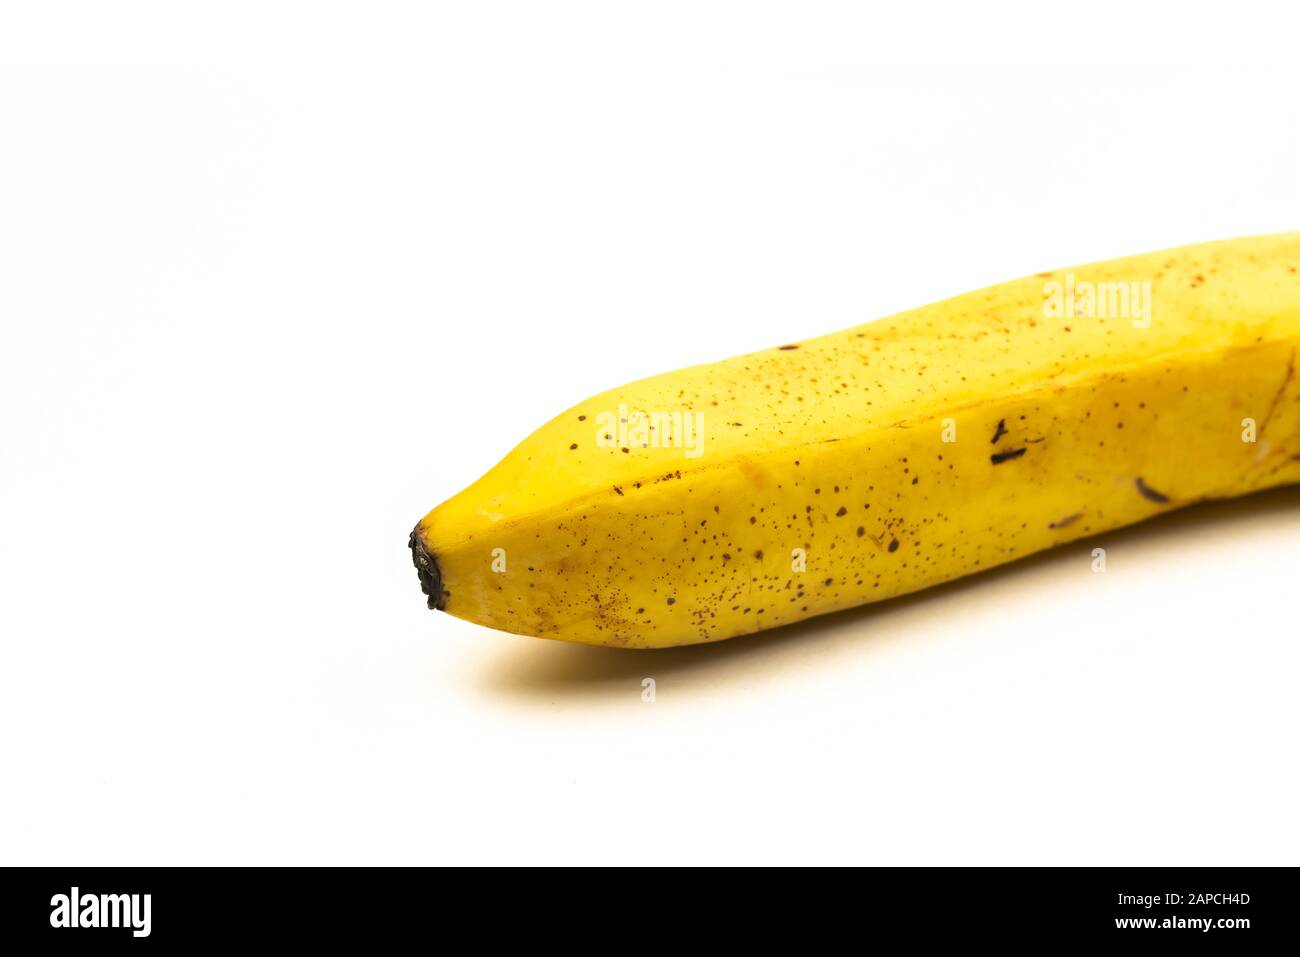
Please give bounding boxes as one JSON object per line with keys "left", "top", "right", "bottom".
{"left": 411, "top": 233, "right": 1300, "bottom": 648}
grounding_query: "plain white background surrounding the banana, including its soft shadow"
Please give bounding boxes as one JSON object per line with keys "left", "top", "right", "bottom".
{"left": 0, "top": 3, "right": 1300, "bottom": 865}
